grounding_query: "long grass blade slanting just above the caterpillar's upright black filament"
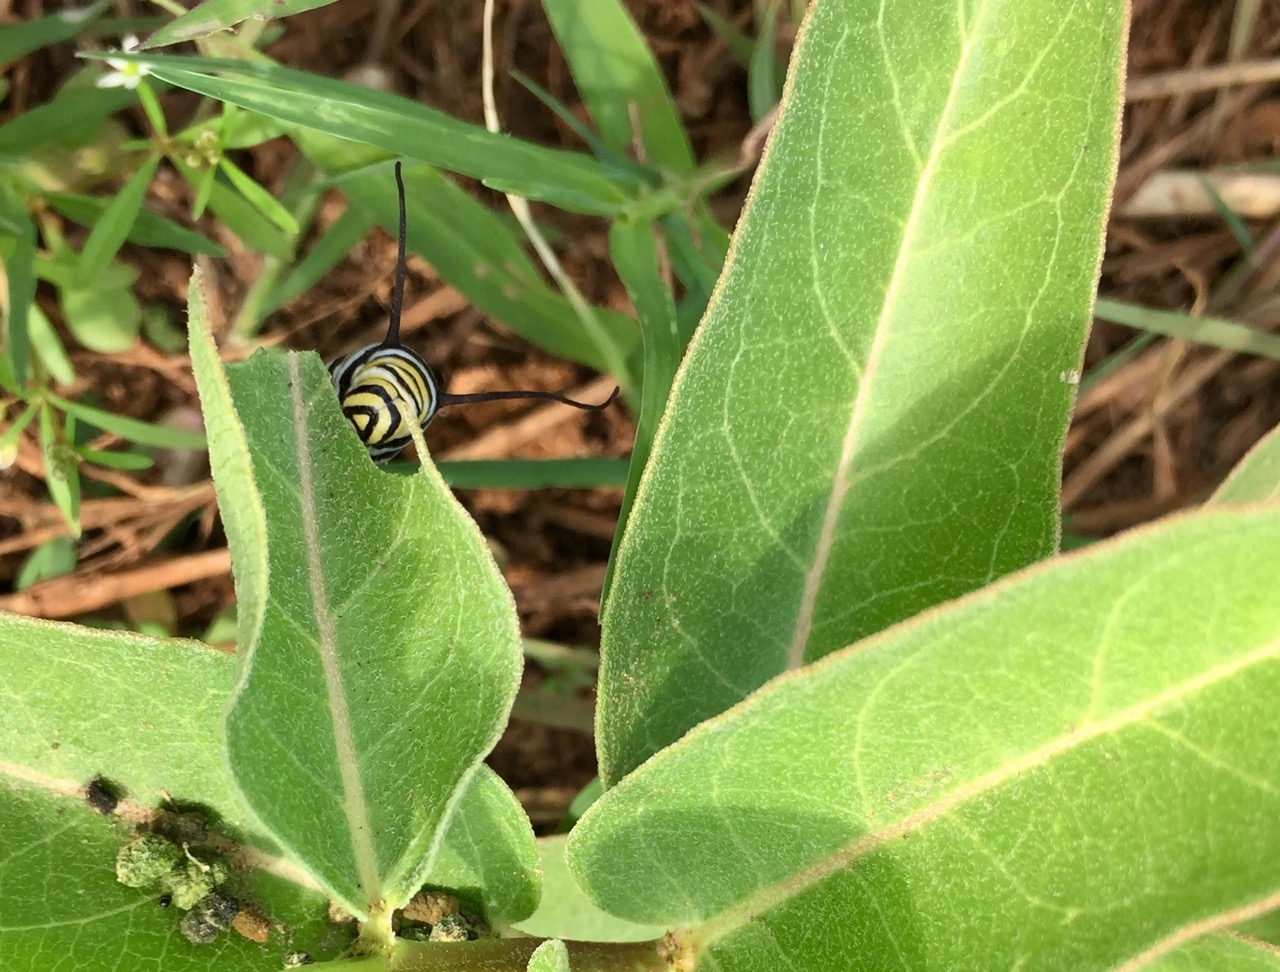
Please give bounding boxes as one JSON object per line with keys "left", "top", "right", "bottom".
{"left": 113, "top": 55, "right": 639, "bottom": 214}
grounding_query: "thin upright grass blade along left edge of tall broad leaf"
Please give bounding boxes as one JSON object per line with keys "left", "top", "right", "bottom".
{"left": 600, "top": 219, "right": 684, "bottom": 601}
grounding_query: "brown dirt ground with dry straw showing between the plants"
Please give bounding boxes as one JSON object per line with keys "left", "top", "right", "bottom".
{"left": 0, "top": 0, "right": 1280, "bottom": 826}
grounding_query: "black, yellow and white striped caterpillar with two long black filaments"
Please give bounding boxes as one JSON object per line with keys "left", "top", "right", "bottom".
{"left": 329, "top": 161, "right": 618, "bottom": 462}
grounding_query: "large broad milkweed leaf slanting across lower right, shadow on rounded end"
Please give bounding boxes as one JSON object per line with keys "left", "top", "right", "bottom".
{"left": 568, "top": 507, "right": 1280, "bottom": 971}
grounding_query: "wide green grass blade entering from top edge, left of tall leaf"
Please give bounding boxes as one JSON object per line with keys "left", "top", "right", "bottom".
{"left": 543, "top": 0, "right": 694, "bottom": 173}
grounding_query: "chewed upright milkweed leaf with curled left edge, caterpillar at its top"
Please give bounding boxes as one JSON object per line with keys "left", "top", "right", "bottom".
{"left": 191, "top": 270, "right": 521, "bottom": 916}
